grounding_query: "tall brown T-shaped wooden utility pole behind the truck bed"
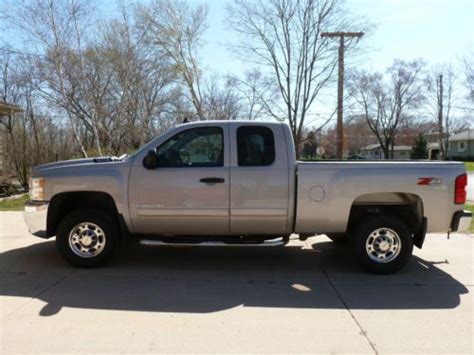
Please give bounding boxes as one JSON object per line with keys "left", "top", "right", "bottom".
{"left": 321, "top": 32, "right": 364, "bottom": 159}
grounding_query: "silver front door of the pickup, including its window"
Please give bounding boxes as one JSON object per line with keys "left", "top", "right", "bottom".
{"left": 129, "top": 123, "right": 230, "bottom": 235}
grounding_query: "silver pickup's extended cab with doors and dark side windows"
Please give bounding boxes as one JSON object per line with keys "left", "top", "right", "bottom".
{"left": 128, "top": 121, "right": 295, "bottom": 236}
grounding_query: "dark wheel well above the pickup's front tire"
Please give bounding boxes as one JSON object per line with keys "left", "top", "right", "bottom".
{"left": 46, "top": 191, "right": 118, "bottom": 237}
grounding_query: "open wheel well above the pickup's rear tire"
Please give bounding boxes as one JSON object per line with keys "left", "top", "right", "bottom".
{"left": 347, "top": 193, "right": 423, "bottom": 232}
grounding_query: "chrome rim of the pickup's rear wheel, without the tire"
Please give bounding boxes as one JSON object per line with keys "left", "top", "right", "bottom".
{"left": 365, "top": 228, "right": 402, "bottom": 264}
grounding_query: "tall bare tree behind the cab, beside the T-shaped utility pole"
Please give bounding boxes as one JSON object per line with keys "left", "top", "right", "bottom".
{"left": 228, "top": 0, "right": 360, "bottom": 152}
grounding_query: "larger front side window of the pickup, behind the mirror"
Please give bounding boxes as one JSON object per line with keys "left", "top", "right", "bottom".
{"left": 156, "top": 127, "right": 224, "bottom": 168}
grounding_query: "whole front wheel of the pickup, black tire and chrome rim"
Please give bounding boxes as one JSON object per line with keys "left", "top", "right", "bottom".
{"left": 56, "top": 210, "right": 119, "bottom": 267}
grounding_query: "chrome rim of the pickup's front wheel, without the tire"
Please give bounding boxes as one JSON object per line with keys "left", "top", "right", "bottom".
{"left": 69, "top": 222, "right": 106, "bottom": 258}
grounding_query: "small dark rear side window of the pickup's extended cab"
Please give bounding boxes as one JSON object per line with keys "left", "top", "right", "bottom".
{"left": 237, "top": 126, "right": 275, "bottom": 166}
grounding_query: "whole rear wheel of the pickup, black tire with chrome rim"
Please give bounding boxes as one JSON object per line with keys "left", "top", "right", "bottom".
{"left": 353, "top": 217, "right": 413, "bottom": 274}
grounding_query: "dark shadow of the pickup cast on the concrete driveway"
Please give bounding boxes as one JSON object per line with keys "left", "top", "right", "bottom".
{"left": 0, "top": 241, "right": 468, "bottom": 316}
